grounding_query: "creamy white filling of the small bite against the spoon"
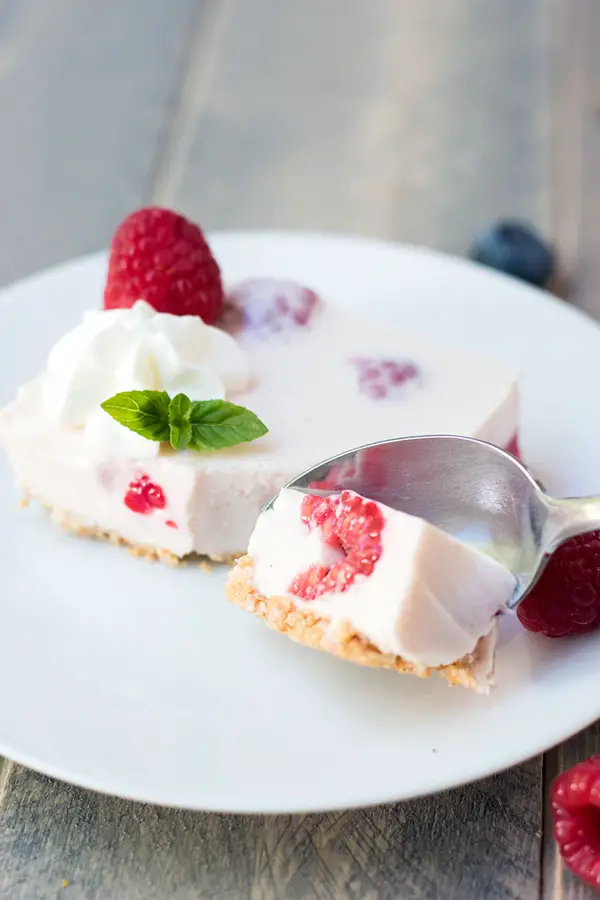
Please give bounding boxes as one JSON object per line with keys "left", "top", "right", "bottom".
{"left": 249, "top": 490, "right": 515, "bottom": 667}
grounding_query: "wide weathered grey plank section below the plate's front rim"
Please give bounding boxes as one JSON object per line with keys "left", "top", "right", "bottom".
{"left": 0, "top": 763, "right": 540, "bottom": 900}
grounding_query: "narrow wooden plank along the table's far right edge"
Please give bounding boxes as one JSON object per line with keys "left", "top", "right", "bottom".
{"left": 542, "top": 0, "right": 600, "bottom": 900}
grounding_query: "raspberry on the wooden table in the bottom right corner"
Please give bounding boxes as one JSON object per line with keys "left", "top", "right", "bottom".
{"left": 550, "top": 756, "right": 600, "bottom": 888}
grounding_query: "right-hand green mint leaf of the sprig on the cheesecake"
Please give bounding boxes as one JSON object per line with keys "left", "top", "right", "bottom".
{"left": 188, "top": 400, "right": 268, "bottom": 451}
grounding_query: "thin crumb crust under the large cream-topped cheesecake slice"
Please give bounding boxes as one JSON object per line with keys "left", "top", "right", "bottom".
{"left": 20, "top": 492, "right": 240, "bottom": 572}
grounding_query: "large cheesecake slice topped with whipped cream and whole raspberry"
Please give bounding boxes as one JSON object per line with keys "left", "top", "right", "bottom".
{"left": 0, "top": 209, "right": 519, "bottom": 561}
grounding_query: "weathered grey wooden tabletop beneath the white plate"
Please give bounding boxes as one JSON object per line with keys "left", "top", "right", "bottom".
{"left": 0, "top": 0, "right": 600, "bottom": 900}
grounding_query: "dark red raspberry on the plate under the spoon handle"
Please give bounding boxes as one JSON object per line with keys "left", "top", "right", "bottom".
{"left": 517, "top": 531, "right": 600, "bottom": 637}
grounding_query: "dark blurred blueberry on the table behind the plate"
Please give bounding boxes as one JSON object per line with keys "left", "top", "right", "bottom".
{"left": 469, "top": 219, "right": 554, "bottom": 287}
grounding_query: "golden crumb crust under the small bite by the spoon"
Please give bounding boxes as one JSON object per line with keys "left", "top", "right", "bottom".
{"left": 225, "top": 555, "right": 489, "bottom": 693}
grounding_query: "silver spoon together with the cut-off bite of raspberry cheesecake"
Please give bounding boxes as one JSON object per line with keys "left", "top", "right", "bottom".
{"left": 227, "top": 435, "right": 600, "bottom": 693}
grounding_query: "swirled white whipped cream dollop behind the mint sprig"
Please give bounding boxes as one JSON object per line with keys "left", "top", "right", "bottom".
{"left": 42, "top": 300, "right": 249, "bottom": 457}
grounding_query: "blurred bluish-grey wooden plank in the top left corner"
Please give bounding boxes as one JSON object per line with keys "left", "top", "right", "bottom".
{"left": 0, "top": 0, "right": 203, "bottom": 283}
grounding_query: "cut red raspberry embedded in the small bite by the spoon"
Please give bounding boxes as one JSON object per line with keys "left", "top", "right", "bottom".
{"left": 290, "top": 491, "right": 385, "bottom": 600}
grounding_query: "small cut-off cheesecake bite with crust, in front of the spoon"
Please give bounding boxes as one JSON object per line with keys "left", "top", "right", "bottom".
{"left": 227, "top": 489, "right": 515, "bottom": 693}
